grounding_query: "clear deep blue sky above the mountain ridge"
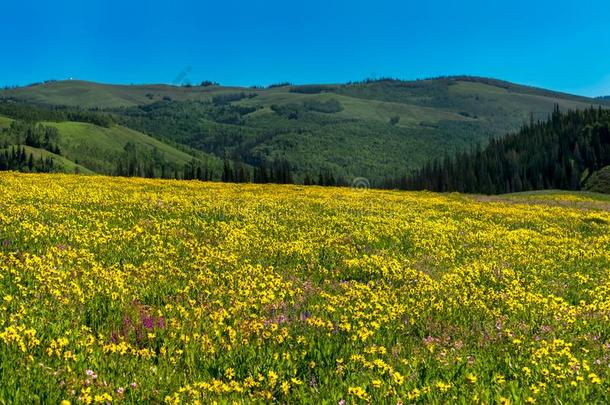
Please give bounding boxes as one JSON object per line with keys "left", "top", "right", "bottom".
{"left": 0, "top": 0, "right": 610, "bottom": 95}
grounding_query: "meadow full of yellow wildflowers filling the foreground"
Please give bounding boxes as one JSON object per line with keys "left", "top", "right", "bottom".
{"left": 0, "top": 173, "right": 610, "bottom": 404}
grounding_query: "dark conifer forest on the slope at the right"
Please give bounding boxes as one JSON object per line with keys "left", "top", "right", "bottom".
{"left": 387, "top": 108, "right": 610, "bottom": 194}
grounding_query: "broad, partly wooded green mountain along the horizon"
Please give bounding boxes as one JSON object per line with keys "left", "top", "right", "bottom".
{"left": 0, "top": 76, "right": 610, "bottom": 184}
